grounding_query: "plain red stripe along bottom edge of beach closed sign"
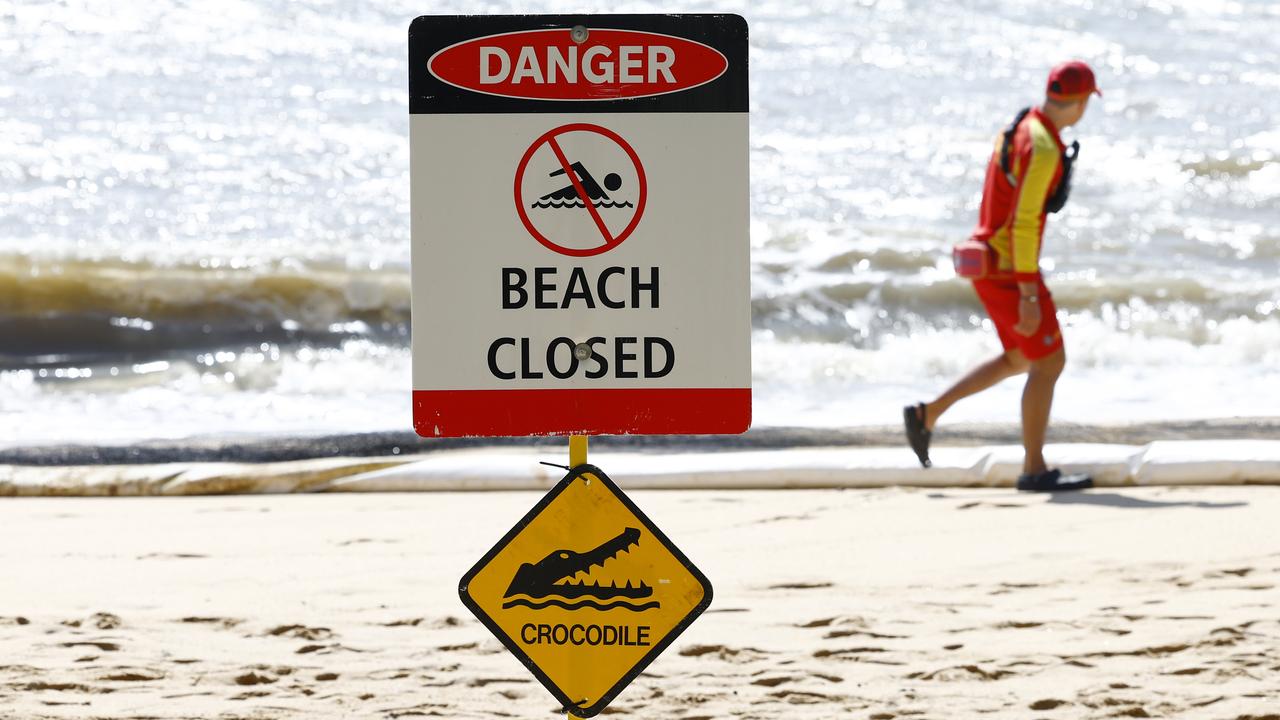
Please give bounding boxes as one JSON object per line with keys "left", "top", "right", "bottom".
{"left": 413, "top": 388, "right": 751, "bottom": 437}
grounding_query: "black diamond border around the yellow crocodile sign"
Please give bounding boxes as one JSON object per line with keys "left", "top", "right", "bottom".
{"left": 458, "top": 464, "right": 712, "bottom": 717}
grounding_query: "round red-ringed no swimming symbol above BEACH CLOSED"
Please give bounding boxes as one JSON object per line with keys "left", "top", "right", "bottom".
{"left": 516, "top": 123, "right": 648, "bottom": 258}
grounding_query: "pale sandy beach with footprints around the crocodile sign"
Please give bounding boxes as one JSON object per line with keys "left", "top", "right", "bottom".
{"left": 0, "top": 484, "right": 1280, "bottom": 720}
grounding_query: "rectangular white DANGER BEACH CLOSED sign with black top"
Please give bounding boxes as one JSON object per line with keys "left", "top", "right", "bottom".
{"left": 408, "top": 15, "right": 751, "bottom": 437}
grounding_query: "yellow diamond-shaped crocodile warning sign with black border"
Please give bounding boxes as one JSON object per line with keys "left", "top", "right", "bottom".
{"left": 458, "top": 465, "right": 712, "bottom": 717}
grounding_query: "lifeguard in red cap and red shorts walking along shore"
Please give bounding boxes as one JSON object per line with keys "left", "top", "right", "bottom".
{"left": 902, "top": 60, "right": 1102, "bottom": 492}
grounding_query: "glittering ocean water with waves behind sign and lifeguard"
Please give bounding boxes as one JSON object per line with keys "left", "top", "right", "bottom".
{"left": 0, "top": 0, "right": 1280, "bottom": 446}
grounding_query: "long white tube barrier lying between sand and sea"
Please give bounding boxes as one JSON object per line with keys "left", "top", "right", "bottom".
{"left": 0, "top": 439, "right": 1280, "bottom": 497}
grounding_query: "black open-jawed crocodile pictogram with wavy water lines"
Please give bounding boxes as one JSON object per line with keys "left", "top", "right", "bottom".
{"left": 502, "top": 528, "right": 660, "bottom": 612}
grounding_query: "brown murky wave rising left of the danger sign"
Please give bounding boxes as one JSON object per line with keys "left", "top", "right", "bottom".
{"left": 0, "top": 256, "right": 410, "bottom": 369}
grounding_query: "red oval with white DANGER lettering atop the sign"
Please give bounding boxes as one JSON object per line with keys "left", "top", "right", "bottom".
{"left": 426, "top": 28, "right": 728, "bottom": 100}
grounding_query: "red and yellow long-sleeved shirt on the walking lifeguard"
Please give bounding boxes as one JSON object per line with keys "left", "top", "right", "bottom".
{"left": 973, "top": 108, "right": 1065, "bottom": 282}
